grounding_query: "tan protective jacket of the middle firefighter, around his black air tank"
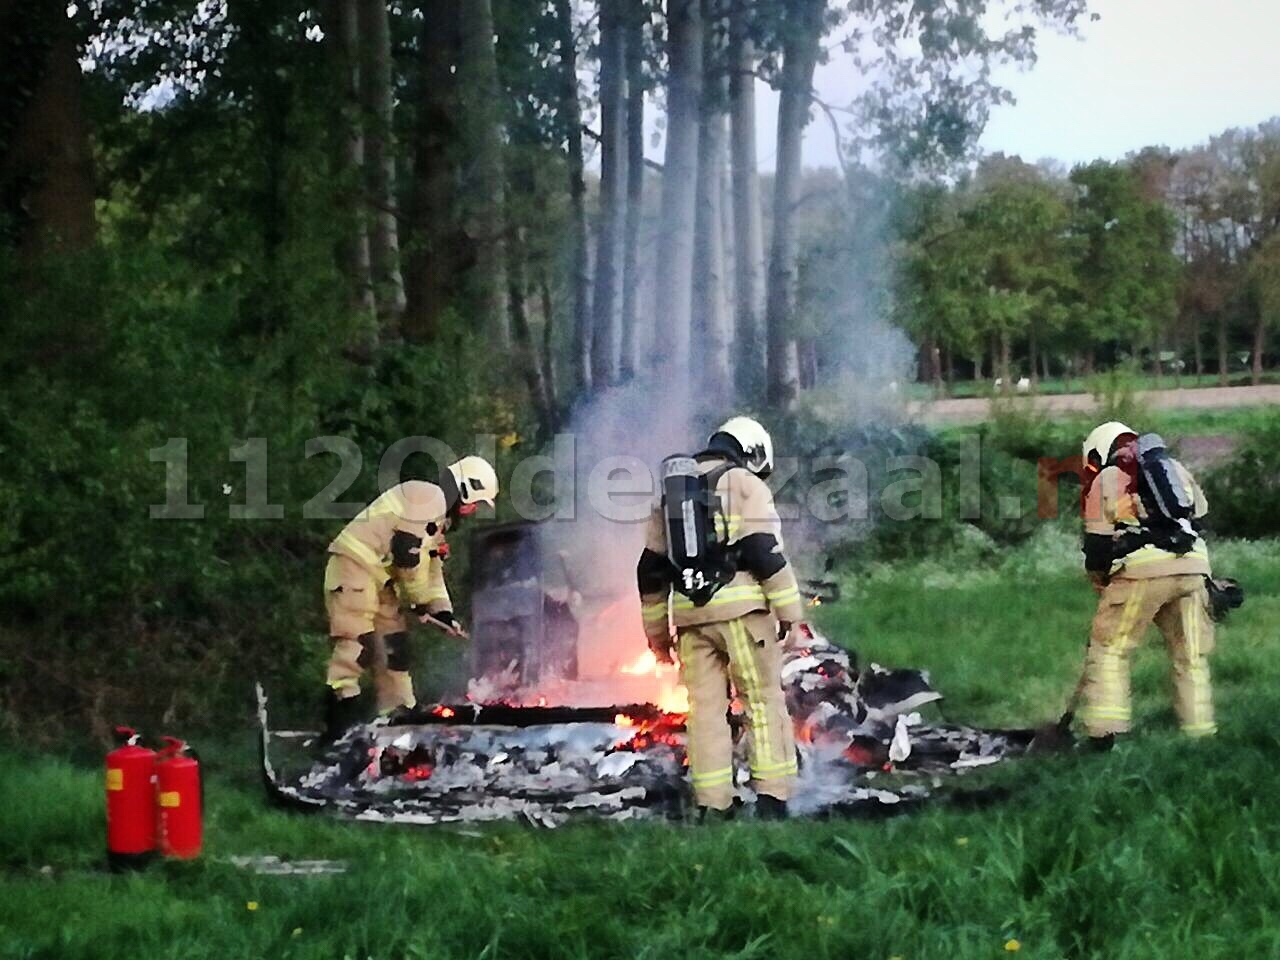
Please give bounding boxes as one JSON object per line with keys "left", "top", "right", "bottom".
{"left": 637, "top": 457, "right": 804, "bottom": 639}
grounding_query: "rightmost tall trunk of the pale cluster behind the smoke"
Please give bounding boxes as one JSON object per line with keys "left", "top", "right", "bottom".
{"left": 764, "top": 0, "right": 827, "bottom": 407}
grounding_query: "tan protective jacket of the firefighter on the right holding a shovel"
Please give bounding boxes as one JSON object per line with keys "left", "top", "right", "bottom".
{"left": 1084, "top": 460, "right": 1210, "bottom": 580}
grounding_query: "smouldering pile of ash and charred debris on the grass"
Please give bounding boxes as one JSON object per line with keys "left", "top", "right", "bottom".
{"left": 260, "top": 636, "right": 1030, "bottom": 827}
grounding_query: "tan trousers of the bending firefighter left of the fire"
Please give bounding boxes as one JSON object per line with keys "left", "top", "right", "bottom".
{"left": 324, "top": 554, "right": 416, "bottom": 713}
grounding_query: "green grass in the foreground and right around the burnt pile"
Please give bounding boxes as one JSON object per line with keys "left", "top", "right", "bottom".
{"left": 0, "top": 531, "right": 1280, "bottom": 960}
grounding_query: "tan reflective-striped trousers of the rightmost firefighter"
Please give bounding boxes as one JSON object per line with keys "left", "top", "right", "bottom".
{"left": 1080, "top": 575, "right": 1217, "bottom": 736}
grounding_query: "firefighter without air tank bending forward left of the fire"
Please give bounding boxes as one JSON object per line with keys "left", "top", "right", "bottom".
{"left": 324, "top": 457, "right": 498, "bottom": 739}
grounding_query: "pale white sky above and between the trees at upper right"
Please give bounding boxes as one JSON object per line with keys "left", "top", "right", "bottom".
{"left": 756, "top": 0, "right": 1280, "bottom": 175}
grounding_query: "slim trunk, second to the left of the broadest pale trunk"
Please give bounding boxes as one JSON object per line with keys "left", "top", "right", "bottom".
{"left": 591, "top": 0, "right": 627, "bottom": 389}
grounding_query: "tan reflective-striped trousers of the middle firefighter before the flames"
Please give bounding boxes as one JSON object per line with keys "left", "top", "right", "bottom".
{"left": 678, "top": 613, "right": 796, "bottom": 810}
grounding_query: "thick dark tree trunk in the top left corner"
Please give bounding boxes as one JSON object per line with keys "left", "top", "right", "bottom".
{"left": 0, "top": 0, "right": 96, "bottom": 260}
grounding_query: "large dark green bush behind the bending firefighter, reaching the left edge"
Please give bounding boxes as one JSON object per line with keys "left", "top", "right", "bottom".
{"left": 0, "top": 247, "right": 524, "bottom": 740}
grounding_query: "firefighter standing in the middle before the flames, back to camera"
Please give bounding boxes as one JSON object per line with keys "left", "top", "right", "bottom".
{"left": 636, "top": 417, "right": 801, "bottom": 819}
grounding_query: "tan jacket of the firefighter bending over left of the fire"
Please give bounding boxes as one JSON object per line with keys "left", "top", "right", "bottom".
{"left": 329, "top": 480, "right": 453, "bottom": 613}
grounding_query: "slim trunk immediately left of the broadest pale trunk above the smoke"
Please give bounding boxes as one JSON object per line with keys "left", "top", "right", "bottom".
{"left": 620, "top": 0, "right": 650, "bottom": 381}
